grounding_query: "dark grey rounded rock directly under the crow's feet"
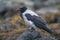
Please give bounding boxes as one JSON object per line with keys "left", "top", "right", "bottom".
{"left": 16, "top": 30, "right": 41, "bottom": 40}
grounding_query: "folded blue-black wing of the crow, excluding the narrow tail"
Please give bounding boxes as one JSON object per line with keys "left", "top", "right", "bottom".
{"left": 25, "top": 14, "right": 47, "bottom": 28}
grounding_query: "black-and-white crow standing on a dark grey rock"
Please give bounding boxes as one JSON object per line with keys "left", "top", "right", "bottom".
{"left": 17, "top": 7, "right": 53, "bottom": 34}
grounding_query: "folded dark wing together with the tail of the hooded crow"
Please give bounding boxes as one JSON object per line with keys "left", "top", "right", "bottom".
{"left": 25, "top": 14, "right": 52, "bottom": 33}
